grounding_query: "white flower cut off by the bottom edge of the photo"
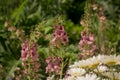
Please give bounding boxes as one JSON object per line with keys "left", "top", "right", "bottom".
{"left": 76, "top": 74, "right": 100, "bottom": 80}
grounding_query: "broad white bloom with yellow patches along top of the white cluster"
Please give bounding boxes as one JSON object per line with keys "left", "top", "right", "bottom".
{"left": 69, "top": 55, "right": 120, "bottom": 68}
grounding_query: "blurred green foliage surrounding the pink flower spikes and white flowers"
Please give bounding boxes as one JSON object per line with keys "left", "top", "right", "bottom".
{"left": 0, "top": 0, "right": 120, "bottom": 80}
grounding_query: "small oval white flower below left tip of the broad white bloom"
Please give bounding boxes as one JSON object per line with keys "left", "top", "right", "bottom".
{"left": 67, "top": 68, "right": 86, "bottom": 76}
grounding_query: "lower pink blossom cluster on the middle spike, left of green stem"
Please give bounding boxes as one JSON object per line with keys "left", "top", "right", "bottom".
{"left": 46, "top": 56, "right": 62, "bottom": 74}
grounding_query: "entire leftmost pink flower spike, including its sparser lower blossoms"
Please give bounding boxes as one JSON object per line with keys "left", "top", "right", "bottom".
{"left": 21, "top": 40, "right": 41, "bottom": 79}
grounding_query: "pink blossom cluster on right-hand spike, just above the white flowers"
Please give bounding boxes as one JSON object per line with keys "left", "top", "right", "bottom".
{"left": 79, "top": 30, "right": 97, "bottom": 56}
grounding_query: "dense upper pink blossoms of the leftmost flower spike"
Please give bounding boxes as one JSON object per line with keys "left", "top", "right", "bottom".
{"left": 21, "top": 40, "right": 38, "bottom": 62}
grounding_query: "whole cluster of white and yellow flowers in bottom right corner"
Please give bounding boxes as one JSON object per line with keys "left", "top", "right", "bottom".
{"left": 63, "top": 55, "right": 120, "bottom": 80}
